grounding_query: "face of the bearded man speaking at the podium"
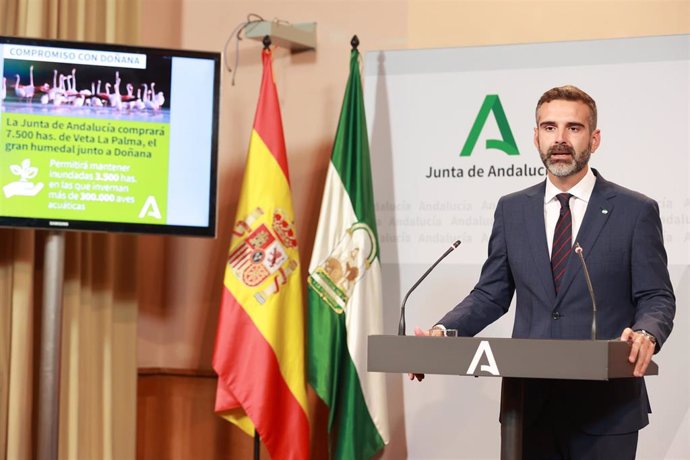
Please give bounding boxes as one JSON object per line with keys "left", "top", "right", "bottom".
{"left": 534, "top": 100, "right": 600, "bottom": 177}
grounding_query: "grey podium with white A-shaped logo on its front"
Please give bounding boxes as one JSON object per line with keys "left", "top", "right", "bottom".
{"left": 367, "top": 335, "right": 659, "bottom": 460}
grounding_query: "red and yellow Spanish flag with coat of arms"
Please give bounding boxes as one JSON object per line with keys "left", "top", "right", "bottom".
{"left": 213, "top": 49, "right": 309, "bottom": 460}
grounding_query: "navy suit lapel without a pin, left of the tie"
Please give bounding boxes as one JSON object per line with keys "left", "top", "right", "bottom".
{"left": 523, "top": 182, "right": 556, "bottom": 304}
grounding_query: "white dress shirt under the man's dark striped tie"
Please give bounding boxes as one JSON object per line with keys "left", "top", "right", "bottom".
{"left": 544, "top": 167, "right": 597, "bottom": 255}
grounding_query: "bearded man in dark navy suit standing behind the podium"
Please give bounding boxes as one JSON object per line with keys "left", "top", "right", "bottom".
{"left": 410, "top": 86, "right": 675, "bottom": 460}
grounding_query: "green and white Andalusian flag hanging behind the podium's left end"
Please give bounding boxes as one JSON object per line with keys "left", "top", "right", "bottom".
{"left": 307, "top": 44, "right": 388, "bottom": 460}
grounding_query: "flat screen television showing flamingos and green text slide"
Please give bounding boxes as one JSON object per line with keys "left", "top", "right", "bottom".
{"left": 0, "top": 37, "right": 220, "bottom": 236}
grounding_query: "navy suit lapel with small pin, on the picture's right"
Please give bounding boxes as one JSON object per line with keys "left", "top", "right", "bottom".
{"left": 556, "top": 170, "right": 615, "bottom": 307}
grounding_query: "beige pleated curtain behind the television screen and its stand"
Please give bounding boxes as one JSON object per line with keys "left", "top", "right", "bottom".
{"left": 0, "top": 0, "right": 139, "bottom": 460}
